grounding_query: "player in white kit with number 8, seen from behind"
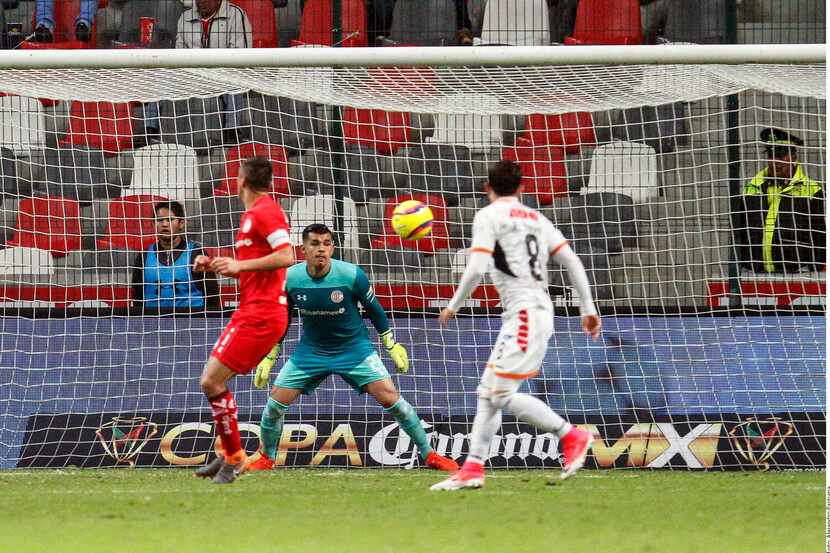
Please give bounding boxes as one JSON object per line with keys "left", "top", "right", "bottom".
{"left": 431, "top": 160, "right": 602, "bottom": 490}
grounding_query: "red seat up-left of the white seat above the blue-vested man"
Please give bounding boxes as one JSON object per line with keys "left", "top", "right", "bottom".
{"left": 61, "top": 102, "right": 133, "bottom": 155}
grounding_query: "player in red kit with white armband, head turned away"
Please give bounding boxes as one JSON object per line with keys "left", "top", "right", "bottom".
{"left": 195, "top": 157, "right": 294, "bottom": 484}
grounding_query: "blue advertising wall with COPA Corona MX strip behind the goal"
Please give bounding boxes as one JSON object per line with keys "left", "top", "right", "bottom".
{"left": 0, "top": 315, "right": 826, "bottom": 468}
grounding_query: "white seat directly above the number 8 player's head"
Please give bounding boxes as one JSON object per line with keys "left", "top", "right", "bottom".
{"left": 426, "top": 93, "right": 503, "bottom": 153}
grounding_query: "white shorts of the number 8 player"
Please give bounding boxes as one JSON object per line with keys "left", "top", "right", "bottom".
{"left": 487, "top": 308, "right": 553, "bottom": 380}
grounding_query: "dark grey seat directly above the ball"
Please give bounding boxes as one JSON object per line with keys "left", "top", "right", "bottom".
{"left": 392, "top": 144, "right": 480, "bottom": 205}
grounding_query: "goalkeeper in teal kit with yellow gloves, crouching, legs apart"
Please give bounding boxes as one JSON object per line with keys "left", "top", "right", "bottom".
{"left": 248, "top": 224, "right": 458, "bottom": 471}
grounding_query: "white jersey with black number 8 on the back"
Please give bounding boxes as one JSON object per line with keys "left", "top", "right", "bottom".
{"left": 471, "top": 196, "right": 567, "bottom": 313}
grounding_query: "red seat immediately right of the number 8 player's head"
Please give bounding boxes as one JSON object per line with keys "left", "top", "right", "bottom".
{"left": 501, "top": 138, "right": 568, "bottom": 205}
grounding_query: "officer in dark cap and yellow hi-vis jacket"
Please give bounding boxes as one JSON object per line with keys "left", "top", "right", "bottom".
{"left": 736, "top": 128, "right": 826, "bottom": 273}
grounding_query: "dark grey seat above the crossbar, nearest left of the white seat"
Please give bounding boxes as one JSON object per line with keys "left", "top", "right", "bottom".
{"left": 389, "top": 0, "right": 459, "bottom": 46}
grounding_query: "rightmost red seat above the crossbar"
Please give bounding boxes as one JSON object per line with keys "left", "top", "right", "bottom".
{"left": 565, "top": 0, "right": 643, "bottom": 45}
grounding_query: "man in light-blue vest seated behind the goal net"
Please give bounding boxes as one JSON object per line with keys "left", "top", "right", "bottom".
{"left": 132, "top": 201, "right": 220, "bottom": 308}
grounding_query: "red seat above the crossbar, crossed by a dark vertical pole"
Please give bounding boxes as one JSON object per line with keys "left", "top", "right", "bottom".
{"left": 291, "top": 0, "right": 368, "bottom": 48}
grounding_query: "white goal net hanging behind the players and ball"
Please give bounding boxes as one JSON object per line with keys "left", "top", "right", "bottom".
{"left": 0, "top": 48, "right": 827, "bottom": 469}
